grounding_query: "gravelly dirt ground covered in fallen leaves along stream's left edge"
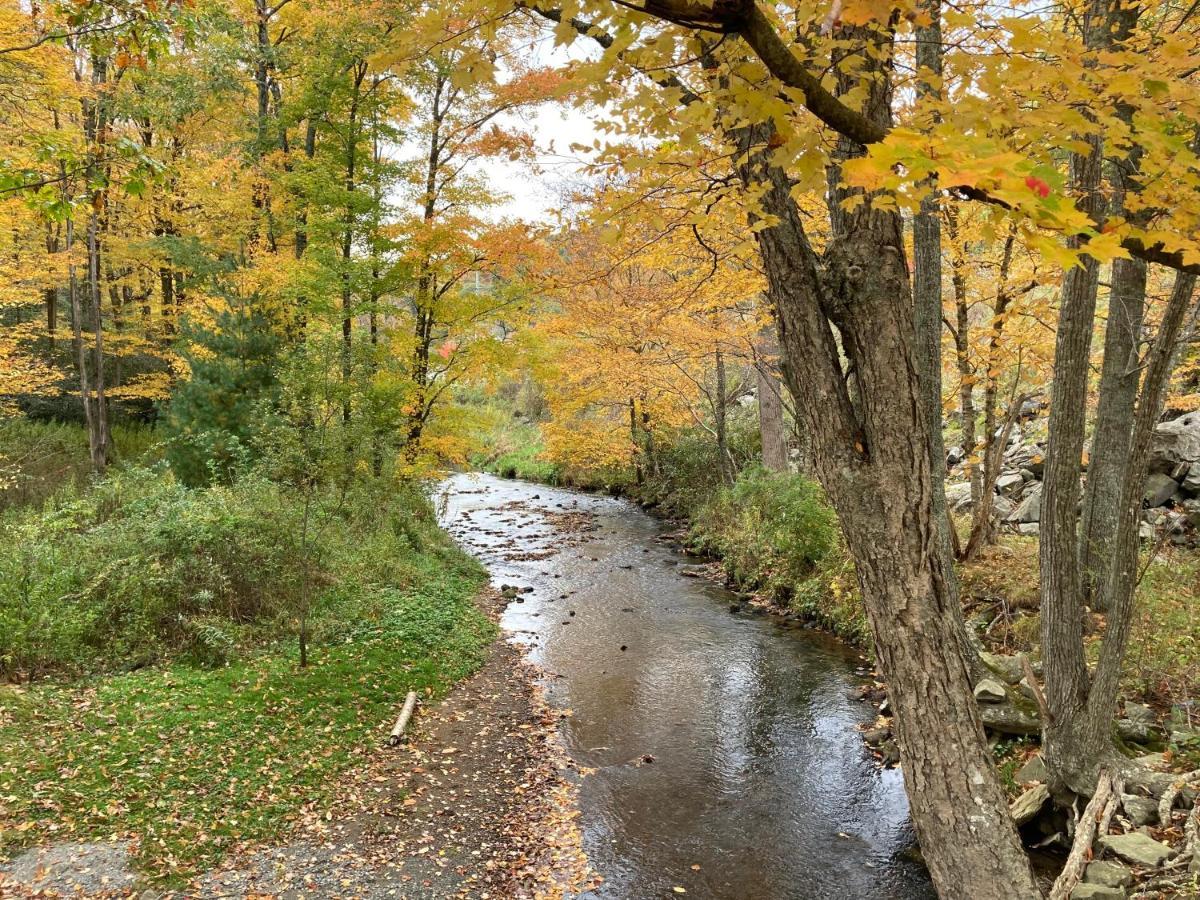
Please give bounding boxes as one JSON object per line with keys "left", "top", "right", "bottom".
{"left": 0, "top": 590, "right": 589, "bottom": 900}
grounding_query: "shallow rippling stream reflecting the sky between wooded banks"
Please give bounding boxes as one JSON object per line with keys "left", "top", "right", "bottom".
{"left": 440, "top": 474, "right": 935, "bottom": 900}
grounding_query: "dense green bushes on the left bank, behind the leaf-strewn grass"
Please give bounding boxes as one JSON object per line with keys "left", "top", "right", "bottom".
{"left": 0, "top": 468, "right": 477, "bottom": 679}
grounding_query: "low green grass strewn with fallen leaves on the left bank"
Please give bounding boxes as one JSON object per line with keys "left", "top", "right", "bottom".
{"left": 0, "top": 557, "right": 494, "bottom": 883}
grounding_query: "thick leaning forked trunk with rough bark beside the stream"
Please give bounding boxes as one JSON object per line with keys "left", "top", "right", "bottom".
{"left": 744, "top": 121, "right": 1038, "bottom": 900}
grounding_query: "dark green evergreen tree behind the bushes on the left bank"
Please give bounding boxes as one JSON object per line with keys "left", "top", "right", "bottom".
{"left": 166, "top": 305, "right": 280, "bottom": 485}
